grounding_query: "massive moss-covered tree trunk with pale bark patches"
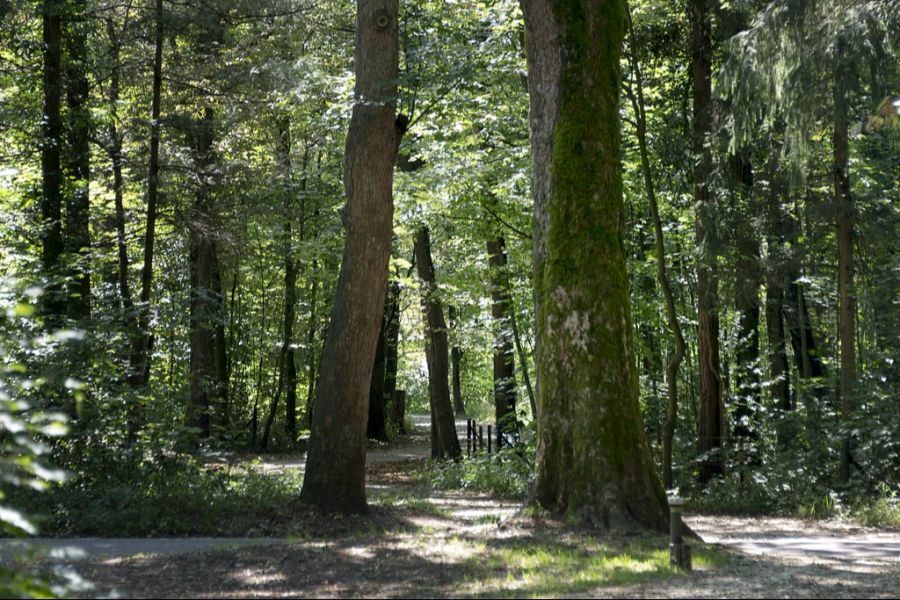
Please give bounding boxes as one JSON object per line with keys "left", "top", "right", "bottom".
{"left": 522, "top": 0, "right": 668, "bottom": 530}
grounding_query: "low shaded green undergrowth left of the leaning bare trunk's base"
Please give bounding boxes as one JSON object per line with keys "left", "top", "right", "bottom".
{"left": 15, "top": 454, "right": 302, "bottom": 536}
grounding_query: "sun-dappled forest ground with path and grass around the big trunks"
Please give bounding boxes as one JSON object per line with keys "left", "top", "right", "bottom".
{"left": 8, "top": 422, "right": 900, "bottom": 598}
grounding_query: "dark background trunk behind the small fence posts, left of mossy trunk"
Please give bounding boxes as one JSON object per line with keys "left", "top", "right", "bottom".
{"left": 487, "top": 236, "right": 518, "bottom": 432}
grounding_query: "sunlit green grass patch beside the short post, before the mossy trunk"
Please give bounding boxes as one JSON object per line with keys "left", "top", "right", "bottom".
{"left": 469, "top": 537, "right": 729, "bottom": 597}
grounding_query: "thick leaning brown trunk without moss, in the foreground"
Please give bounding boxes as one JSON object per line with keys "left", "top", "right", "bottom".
{"left": 300, "top": 0, "right": 399, "bottom": 512}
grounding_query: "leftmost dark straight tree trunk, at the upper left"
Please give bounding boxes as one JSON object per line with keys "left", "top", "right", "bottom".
{"left": 40, "top": 0, "right": 66, "bottom": 326}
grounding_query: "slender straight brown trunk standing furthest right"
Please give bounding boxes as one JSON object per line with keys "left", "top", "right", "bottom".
{"left": 832, "top": 38, "right": 856, "bottom": 483}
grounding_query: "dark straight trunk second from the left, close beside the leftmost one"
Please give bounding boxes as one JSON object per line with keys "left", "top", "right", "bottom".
{"left": 64, "top": 0, "right": 91, "bottom": 321}
